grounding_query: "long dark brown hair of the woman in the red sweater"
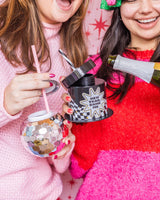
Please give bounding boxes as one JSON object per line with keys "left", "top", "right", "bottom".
{"left": 96, "top": 5, "right": 160, "bottom": 102}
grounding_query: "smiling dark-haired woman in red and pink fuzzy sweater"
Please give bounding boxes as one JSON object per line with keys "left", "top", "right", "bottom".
{"left": 61, "top": 0, "right": 160, "bottom": 200}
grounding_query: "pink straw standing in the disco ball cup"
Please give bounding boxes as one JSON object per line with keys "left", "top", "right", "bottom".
{"left": 31, "top": 45, "right": 50, "bottom": 113}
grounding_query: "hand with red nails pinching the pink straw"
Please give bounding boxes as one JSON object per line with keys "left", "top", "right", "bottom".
{"left": 4, "top": 73, "right": 55, "bottom": 115}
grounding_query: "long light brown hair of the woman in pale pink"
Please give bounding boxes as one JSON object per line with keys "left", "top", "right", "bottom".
{"left": 0, "top": 0, "right": 89, "bottom": 73}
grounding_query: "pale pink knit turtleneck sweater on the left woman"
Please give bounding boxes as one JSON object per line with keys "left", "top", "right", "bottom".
{"left": 0, "top": 24, "right": 71, "bottom": 200}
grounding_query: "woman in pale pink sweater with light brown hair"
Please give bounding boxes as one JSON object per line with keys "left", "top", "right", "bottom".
{"left": 0, "top": 0, "right": 88, "bottom": 200}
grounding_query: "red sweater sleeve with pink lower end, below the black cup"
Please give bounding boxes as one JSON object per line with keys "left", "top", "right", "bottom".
{"left": 70, "top": 121, "right": 102, "bottom": 178}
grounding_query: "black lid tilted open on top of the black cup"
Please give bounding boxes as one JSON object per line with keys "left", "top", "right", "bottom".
{"left": 62, "top": 60, "right": 96, "bottom": 88}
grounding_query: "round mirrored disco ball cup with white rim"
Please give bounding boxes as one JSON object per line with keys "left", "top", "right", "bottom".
{"left": 21, "top": 111, "right": 68, "bottom": 157}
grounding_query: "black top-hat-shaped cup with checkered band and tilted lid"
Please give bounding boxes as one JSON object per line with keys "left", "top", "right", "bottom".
{"left": 62, "top": 60, "right": 113, "bottom": 123}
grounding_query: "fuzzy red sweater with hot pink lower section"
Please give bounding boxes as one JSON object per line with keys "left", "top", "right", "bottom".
{"left": 70, "top": 50, "right": 160, "bottom": 200}
